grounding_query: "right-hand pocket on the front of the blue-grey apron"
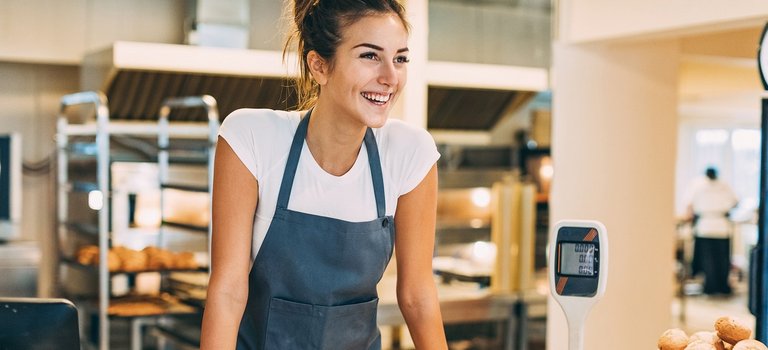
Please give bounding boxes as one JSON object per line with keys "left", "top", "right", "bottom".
{"left": 319, "top": 298, "right": 381, "bottom": 350}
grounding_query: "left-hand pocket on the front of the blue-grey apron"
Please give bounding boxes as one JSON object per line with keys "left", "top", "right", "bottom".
{"left": 264, "top": 298, "right": 319, "bottom": 350}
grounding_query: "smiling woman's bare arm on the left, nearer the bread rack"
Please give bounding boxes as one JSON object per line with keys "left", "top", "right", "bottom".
{"left": 200, "top": 137, "right": 259, "bottom": 350}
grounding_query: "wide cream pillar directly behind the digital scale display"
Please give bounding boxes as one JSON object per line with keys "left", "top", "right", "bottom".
{"left": 547, "top": 41, "right": 679, "bottom": 350}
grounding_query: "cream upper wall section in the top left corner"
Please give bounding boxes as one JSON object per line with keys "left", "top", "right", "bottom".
{"left": 0, "top": 0, "right": 186, "bottom": 64}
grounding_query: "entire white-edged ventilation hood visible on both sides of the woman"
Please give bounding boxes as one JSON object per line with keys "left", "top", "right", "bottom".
{"left": 81, "top": 41, "right": 548, "bottom": 131}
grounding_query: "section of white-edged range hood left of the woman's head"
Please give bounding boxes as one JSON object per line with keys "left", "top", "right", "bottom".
{"left": 81, "top": 42, "right": 296, "bottom": 121}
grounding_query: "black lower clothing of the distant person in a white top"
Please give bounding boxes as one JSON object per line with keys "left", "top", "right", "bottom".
{"left": 691, "top": 237, "right": 731, "bottom": 294}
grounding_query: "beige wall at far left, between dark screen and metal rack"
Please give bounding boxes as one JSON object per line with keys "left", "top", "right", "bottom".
{"left": 0, "top": 62, "right": 79, "bottom": 296}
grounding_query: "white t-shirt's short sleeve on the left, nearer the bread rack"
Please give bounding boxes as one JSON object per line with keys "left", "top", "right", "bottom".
{"left": 219, "top": 109, "right": 261, "bottom": 180}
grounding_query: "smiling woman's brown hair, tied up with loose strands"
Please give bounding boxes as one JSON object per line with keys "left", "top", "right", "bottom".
{"left": 283, "top": 0, "right": 409, "bottom": 109}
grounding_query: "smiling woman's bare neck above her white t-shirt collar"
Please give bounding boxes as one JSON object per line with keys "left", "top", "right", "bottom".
{"left": 306, "top": 102, "right": 366, "bottom": 176}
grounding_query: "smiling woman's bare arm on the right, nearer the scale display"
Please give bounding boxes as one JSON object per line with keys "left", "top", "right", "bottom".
{"left": 395, "top": 166, "right": 448, "bottom": 350}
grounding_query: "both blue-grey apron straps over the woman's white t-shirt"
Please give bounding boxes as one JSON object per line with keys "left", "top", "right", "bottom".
{"left": 277, "top": 109, "right": 386, "bottom": 218}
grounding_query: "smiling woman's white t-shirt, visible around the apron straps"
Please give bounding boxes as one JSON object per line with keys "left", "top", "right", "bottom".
{"left": 219, "top": 109, "right": 440, "bottom": 259}
